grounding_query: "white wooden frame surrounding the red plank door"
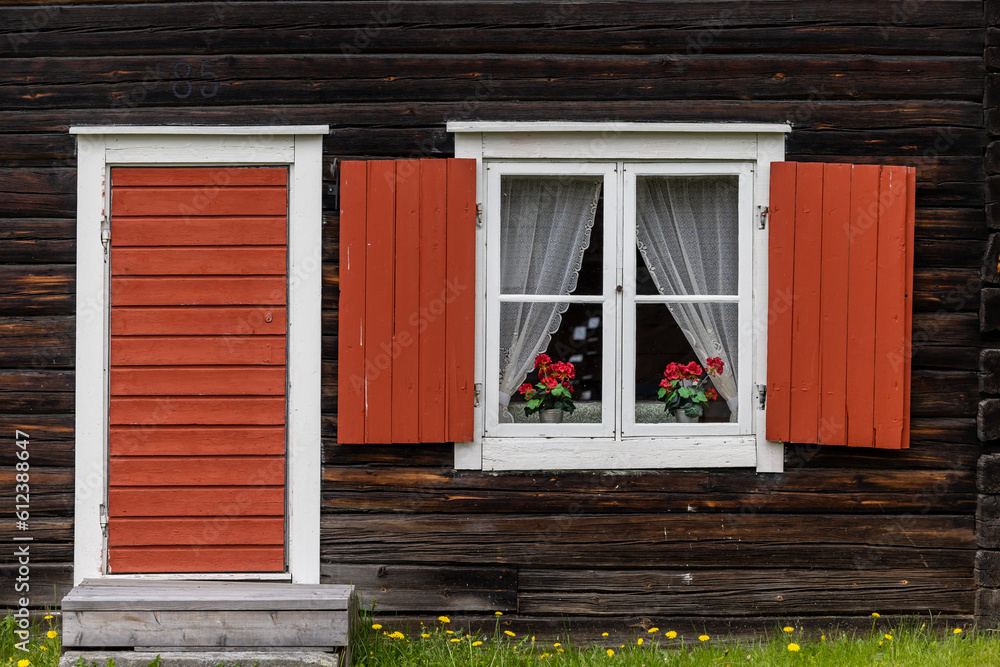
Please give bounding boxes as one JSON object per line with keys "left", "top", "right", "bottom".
{"left": 70, "top": 125, "right": 329, "bottom": 584}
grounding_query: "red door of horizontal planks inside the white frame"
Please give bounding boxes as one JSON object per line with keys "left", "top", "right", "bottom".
{"left": 110, "top": 167, "right": 288, "bottom": 573}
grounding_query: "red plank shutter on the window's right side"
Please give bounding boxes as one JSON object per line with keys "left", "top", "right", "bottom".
{"left": 767, "top": 162, "right": 916, "bottom": 449}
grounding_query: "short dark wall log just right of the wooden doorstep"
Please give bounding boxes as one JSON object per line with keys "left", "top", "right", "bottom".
{"left": 320, "top": 563, "right": 518, "bottom": 614}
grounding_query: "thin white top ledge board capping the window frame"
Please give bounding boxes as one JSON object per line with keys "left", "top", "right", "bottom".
{"left": 447, "top": 121, "right": 792, "bottom": 134}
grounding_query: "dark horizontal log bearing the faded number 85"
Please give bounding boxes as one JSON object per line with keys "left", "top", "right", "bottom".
{"left": 0, "top": 54, "right": 990, "bottom": 109}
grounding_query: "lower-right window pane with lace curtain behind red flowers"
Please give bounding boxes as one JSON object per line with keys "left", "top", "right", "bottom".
{"left": 635, "top": 303, "right": 739, "bottom": 424}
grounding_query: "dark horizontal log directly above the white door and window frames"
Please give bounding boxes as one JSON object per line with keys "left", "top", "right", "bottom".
{"left": 0, "top": 100, "right": 983, "bottom": 136}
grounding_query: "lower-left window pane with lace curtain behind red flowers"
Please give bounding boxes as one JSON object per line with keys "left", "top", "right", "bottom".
{"left": 500, "top": 303, "right": 600, "bottom": 423}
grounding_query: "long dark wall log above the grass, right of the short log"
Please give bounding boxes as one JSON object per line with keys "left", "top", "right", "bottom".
{"left": 518, "top": 568, "right": 975, "bottom": 617}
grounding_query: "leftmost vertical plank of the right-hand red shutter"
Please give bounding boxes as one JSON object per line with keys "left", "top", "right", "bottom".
{"left": 766, "top": 162, "right": 797, "bottom": 442}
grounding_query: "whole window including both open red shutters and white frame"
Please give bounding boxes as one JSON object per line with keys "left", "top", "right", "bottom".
{"left": 338, "top": 123, "right": 915, "bottom": 472}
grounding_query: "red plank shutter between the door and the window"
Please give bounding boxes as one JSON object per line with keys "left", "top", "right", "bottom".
{"left": 337, "top": 159, "right": 476, "bottom": 443}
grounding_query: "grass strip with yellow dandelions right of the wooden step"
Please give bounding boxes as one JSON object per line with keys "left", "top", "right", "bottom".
{"left": 352, "top": 615, "right": 1000, "bottom": 667}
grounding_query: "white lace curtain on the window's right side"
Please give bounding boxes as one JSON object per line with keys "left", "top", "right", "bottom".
{"left": 636, "top": 176, "right": 739, "bottom": 422}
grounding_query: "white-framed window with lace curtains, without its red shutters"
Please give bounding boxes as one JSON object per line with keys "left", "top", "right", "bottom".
{"left": 449, "top": 123, "right": 787, "bottom": 469}
